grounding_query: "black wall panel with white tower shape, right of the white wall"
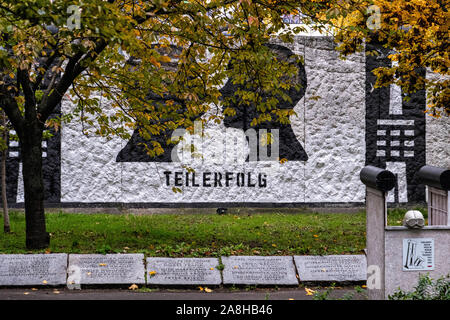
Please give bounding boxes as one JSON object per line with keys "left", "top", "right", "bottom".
{"left": 366, "top": 44, "right": 426, "bottom": 202}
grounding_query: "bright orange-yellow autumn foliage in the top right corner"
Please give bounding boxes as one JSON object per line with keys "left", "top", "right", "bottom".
{"left": 310, "top": 0, "right": 450, "bottom": 117}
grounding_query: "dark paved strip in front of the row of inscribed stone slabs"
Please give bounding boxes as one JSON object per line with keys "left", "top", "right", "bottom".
{"left": 0, "top": 287, "right": 366, "bottom": 301}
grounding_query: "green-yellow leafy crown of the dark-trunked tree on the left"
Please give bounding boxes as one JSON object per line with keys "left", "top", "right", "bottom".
{"left": 0, "top": 0, "right": 322, "bottom": 154}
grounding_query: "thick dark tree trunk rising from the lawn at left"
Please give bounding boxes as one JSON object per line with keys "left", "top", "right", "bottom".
{"left": 20, "top": 119, "right": 50, "bottom": 249}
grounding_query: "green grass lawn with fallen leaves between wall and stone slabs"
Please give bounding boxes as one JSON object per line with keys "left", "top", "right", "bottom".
{"left": 0, "top": 209, "right": 423, "bottom": 257}
